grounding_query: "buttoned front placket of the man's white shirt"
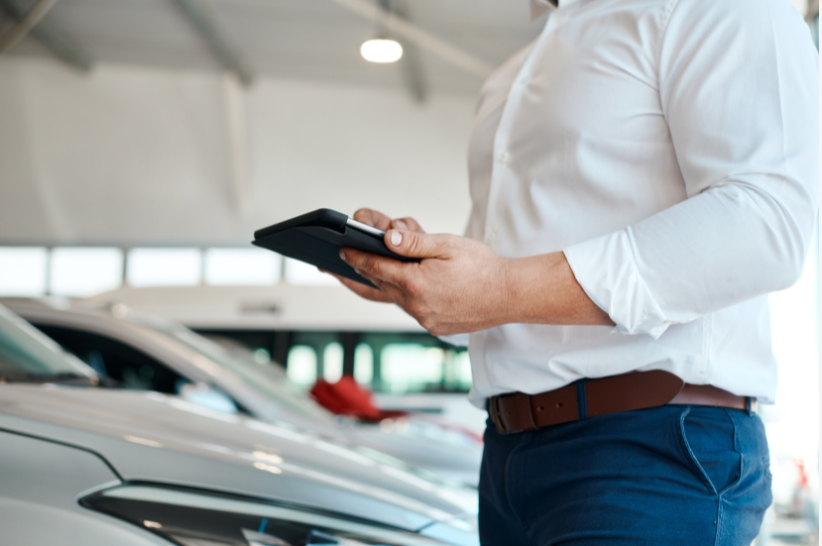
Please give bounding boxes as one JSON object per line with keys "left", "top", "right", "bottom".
{"left": 483, "top": 10, "right": 561, "bottom": 249}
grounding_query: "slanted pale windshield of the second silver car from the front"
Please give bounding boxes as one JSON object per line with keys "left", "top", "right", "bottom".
{"left": 123, "top": 313, "right": 334, "bottom": 422}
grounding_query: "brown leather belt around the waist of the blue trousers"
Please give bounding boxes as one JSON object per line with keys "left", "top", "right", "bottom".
{"left": 488, "top": 370, "right": 756, "bottom": 434}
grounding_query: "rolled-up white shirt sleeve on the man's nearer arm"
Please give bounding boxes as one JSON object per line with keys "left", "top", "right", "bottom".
{"left": 564, "top": 0, "right": 819, "bottom": 338}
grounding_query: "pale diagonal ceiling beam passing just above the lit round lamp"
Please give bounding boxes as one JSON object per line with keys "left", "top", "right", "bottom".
{"left": 330, "top": 0, "right": 494, "bottom": 79}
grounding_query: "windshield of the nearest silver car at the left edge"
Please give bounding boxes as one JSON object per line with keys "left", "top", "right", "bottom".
{"left": 0, "top": 305, "right": 97, "bottom": 384}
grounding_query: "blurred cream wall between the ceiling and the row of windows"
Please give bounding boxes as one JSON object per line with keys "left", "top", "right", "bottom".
{"left": 0, "top": 57, "right": 475, "bottom": 244}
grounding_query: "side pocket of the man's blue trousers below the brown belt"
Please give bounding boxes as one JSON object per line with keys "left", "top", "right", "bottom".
{"left": 679, "top": 406, "right": 742, "bottom": 495}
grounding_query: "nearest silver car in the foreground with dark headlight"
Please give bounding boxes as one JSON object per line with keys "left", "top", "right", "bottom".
{"left": 0, "top": 306, "right": 478, "bottom": 546}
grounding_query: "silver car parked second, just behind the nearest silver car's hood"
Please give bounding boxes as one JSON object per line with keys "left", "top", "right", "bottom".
{"left": 0, "top": 299, "right": 482, "bottom": 487}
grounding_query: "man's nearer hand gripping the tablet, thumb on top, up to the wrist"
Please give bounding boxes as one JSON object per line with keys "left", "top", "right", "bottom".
{"left": 341, "top": 229, "right": 509, "bottom": 335}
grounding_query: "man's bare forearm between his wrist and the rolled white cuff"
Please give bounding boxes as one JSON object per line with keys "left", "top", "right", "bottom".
{"left": 504, "top": 252, "right": 614, "bottom": 326}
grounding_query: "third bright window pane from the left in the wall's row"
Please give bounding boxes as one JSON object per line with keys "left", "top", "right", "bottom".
{"left": 126, "top": 248, "right": 202, "bottom": 287}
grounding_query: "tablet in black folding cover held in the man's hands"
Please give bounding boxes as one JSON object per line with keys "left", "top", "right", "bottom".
{"left": 252, "top": 209, "right": 419, "bottom": 288}
